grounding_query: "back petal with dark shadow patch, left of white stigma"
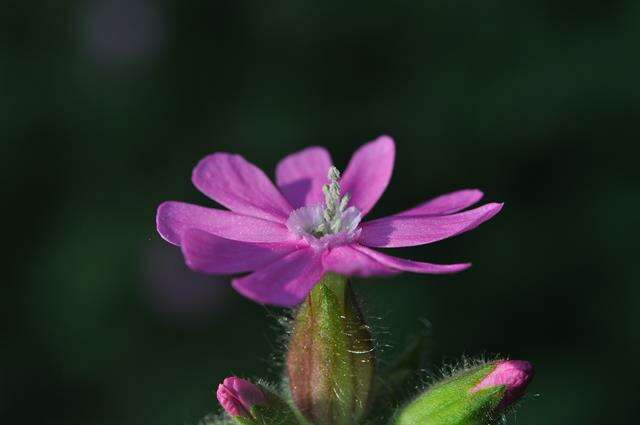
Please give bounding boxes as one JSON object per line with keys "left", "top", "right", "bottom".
{"left": 276, "top": 146, "right": 332, "bottom": 208}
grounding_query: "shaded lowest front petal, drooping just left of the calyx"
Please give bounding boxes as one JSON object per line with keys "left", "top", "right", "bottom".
{"left": 232, "top": 248, "right": 324, "bottom": 307}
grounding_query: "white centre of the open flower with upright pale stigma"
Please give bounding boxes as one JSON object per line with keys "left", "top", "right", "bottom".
{"left": 287, "top": 167, "right": 362, "bottom": 249}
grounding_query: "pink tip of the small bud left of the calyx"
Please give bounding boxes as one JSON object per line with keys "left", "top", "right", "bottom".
{"left": 216, "top": 376, "right": 266, "bottom": 417}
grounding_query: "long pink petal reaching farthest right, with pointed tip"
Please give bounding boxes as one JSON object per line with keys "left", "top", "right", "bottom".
{"left": 359, "top": 203, "right": 502, "bottom": 248}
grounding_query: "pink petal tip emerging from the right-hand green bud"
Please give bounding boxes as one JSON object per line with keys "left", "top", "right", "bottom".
{"left": 471, "top": 360, "right": 533, "bottom": 409}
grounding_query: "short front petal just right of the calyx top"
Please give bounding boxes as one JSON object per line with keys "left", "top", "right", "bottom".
{"left": 322, "top": 245, "right": 400, "bottom": 277}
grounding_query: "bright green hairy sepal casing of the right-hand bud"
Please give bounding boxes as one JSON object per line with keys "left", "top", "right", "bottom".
{"left": 394, "top": 363, "right": 505, "bottom": 425}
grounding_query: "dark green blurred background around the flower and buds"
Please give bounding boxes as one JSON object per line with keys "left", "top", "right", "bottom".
{"left": 0, "top": 0, "right": 640, "bottom": 425}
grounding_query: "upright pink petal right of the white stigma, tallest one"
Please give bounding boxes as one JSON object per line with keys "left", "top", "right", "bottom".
{"left": 340, "top": 136, "right": 396, "bottom": 216}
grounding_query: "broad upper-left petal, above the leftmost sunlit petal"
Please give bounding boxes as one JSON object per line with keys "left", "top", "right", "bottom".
{"left": 191, "top": 153, "right": 292, "bottom": 223}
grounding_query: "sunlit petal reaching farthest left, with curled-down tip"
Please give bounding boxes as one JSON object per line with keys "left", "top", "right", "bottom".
{"left": 156, "top": 201, "right": 293, "bottom": 245}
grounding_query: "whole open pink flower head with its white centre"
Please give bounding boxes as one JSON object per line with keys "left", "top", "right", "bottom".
{"left": 156, "top": 136, "right": 502, "bottom": 306}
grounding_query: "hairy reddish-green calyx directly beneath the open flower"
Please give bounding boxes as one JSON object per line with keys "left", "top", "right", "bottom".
{"left": 287, "top": 274, "right": 375, "bottom": 425}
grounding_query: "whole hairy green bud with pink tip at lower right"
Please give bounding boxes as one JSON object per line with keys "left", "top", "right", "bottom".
{"left": 395, "top": 360, "right": 533, "bottom": 425}
